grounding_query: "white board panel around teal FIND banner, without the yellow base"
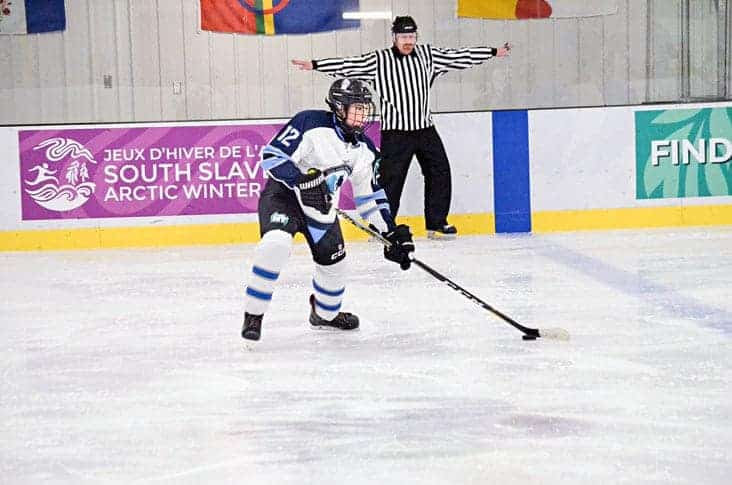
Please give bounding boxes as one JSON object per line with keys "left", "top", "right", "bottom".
{"left": 529, "top": 103, "right": 732, "bottom": 212}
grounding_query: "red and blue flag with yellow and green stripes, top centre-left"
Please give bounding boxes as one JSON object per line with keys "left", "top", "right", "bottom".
{"left": 201, "top": 0, "right": 361, "bottom": 35}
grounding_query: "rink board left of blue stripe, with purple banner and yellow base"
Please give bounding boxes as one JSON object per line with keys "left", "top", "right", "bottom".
{"left": 0, "top": 112, "right": 494, "bottom": 250}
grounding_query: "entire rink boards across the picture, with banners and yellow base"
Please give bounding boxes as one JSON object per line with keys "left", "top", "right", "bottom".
{"left": 0, "top": 103, "right": 732, "bottom": 250}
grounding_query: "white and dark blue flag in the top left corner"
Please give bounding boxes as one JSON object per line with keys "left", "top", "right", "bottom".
{"left": 0, "top": 0, "right": 66, "bottom": 34}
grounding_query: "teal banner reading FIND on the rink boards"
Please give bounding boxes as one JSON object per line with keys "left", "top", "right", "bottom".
{"left": 635, "top": 107, "right": 732, "bottom": 199}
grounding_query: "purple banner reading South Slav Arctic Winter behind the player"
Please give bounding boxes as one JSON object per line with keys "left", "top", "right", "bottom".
{"left": 18, "top": 123, "right": 378, "bottom": 220}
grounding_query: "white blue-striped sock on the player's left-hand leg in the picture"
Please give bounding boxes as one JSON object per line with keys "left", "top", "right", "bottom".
{"left": 245, "top": 230, "right": 292, "bottom": 315}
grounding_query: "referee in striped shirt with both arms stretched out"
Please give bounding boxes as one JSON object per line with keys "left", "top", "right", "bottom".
{"left": 292, "top": 16, "right": 510, "bottom": 239}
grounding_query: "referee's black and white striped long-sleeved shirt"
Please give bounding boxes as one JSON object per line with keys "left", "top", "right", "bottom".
{"left": 313, "top": 44, "right": 496, "bottom": 131}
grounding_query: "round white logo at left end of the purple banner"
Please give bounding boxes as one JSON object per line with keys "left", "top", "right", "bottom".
{"left": 23, "top": 137, "right": 97, "bottom": 212}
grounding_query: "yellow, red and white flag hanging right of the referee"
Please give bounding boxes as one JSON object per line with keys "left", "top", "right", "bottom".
{"left": 458, "top": 0, "right": 618, "bottom": 20}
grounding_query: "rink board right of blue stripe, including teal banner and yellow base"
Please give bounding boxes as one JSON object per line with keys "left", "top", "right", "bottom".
{"left": 529, "top": 103, "right": 732, "bottom": 232}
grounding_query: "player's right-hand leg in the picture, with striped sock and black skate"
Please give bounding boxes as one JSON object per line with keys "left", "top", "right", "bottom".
{"left": 306, "top": 221, "right": 358, "bottom": 330}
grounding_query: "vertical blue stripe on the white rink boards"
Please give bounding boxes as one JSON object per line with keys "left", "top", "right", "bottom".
{"left": 493, "top": 110, "right": 531, "bottom": 232}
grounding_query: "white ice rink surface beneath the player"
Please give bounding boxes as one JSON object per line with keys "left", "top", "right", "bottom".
{"left": 0, "top": 228, "right": 732, "bottom": 485}
